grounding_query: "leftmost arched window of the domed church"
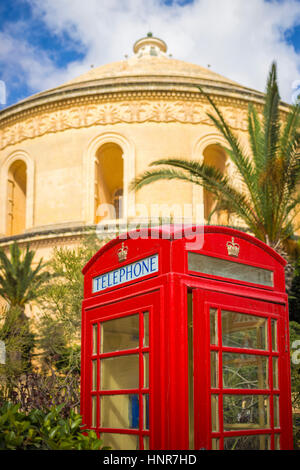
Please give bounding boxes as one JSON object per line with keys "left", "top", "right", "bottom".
{"left": 6, "top": 160, "right": 27, "bottom": 236}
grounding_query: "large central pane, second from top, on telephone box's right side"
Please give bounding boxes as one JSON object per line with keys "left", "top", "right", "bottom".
{"left": 223, "top": 353, "right": 269, "bottom": 389}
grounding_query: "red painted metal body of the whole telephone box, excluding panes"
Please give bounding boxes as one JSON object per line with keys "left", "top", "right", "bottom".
{"left": 81, "top": 226, "right": 292, "bottom": 450}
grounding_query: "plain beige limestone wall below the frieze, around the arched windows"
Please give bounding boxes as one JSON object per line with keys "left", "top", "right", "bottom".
{"left": 1, "top": 111, "right": 234, "bottom": 231}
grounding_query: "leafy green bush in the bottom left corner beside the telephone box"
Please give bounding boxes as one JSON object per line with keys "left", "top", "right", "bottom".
{"left": 0, "top": 402, "right": 108, "bottom": 450}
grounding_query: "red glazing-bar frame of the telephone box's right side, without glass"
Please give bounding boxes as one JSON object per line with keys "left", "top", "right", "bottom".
{"left": 193, "top": 289, "right": 285, "bottom": 450}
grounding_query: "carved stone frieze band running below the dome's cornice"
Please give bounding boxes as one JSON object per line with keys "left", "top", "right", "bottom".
{"left": 0, "top": 99, "right": 251, "bottom": 149}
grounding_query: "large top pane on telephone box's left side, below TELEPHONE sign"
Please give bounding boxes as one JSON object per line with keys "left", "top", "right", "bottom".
{"left": 101, "top": 315, "right": 139, "bottom": 353}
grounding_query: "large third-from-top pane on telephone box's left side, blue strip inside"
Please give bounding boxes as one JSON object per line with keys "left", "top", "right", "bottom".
{"left": 100, "top": 394, "right": 139, "bottom": 429}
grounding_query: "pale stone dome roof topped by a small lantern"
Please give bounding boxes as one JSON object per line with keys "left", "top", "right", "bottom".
{"left": 0, "top": 33, "right": 272, "bottom": 119}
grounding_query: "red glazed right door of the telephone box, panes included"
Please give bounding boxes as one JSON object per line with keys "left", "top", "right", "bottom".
{"left": 193, "top": 289, "right": 292, "bottom": 450}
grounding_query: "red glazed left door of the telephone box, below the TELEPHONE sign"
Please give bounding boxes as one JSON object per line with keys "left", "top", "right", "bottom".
{"left": 82, "top": 292, "right": 159, "bottom": 450}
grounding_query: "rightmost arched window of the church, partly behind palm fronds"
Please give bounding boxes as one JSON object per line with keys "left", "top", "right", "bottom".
{"left": 203, "top": 144, "right": 226, "bottom": 224}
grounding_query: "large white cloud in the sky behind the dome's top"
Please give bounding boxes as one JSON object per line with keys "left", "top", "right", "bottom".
{"left": 0, "top": 0, "right": 300, "bottom": 102}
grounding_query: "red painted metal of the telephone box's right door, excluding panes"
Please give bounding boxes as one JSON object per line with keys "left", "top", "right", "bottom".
{"left": 194, "top": 289, "right": 293, "bottom": 449}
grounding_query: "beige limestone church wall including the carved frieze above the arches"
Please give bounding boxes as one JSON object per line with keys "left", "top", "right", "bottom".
{"left": 0, "top": 94, "right": 296, "bottom": 253}
